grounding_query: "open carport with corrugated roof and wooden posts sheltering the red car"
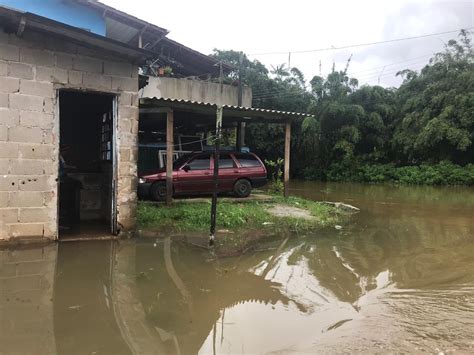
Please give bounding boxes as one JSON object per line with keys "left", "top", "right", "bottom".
{"left": 140, "top": 98, "right": 311, "bottom": 204}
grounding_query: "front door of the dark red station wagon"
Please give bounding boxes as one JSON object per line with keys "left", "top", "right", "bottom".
{"left": 175, "top": 153, "right": 213, "bottom": 193}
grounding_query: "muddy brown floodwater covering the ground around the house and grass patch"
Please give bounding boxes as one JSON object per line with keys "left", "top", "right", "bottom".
{"left": 0, "top": 182, "right": 474, "bottom": 354}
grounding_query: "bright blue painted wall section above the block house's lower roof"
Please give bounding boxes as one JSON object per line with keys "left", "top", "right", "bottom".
{"left": 0, "top": 0, "right": 106, "bottom": 36}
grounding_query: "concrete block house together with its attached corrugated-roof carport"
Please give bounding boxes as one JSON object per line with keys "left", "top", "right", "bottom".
{"left": 0, "top": 0, "right": 302, "bottom": 244}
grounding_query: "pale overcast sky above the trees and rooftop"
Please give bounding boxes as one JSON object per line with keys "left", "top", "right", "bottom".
{"left": 102, "top": 0, "right": 474, "bottom": 86}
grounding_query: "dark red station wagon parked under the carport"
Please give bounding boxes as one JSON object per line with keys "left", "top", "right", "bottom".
{"left": 138, "top": 152, "right": 267, "bottom": 200}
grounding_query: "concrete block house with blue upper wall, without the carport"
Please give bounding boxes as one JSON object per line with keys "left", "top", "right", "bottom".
{"left": 0, "top": 0, "right": 227, "bottom": 242}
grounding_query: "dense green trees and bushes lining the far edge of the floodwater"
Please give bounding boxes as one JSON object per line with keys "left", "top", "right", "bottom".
{"left": 214, "top": 31, "right": 474, "bottom": 185}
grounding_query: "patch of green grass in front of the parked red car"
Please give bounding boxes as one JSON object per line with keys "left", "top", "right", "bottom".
{"left": 138, "top": 196, "right": 342, "bottom": 232}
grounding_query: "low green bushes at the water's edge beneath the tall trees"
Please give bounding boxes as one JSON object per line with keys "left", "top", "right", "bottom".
{"left": 326, "top": 161, "right": 474, "bottom": 186}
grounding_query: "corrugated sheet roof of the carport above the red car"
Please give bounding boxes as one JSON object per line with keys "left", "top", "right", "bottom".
{"left": 140, "top": 97, "right": 314, "bottom": 123}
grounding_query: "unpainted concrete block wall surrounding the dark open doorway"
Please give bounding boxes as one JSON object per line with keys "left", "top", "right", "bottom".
{"left": 0, "top": 29, "right": 138, "bottom": 241}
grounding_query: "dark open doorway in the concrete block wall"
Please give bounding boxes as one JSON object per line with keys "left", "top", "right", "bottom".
{"left": 58, "top": 91, "right": 116, "bottom": 239}
